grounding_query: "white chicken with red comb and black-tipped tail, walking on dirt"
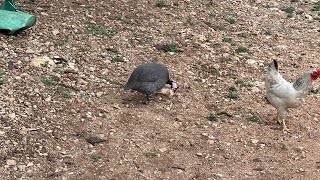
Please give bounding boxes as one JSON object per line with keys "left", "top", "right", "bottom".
{"left": 265, "top": 60, "right": 320, "bottom": 131}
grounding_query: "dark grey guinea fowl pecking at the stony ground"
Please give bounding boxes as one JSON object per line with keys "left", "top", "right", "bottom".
{"left": 124, "top": 63, "right": 178, "bottom": 100}
